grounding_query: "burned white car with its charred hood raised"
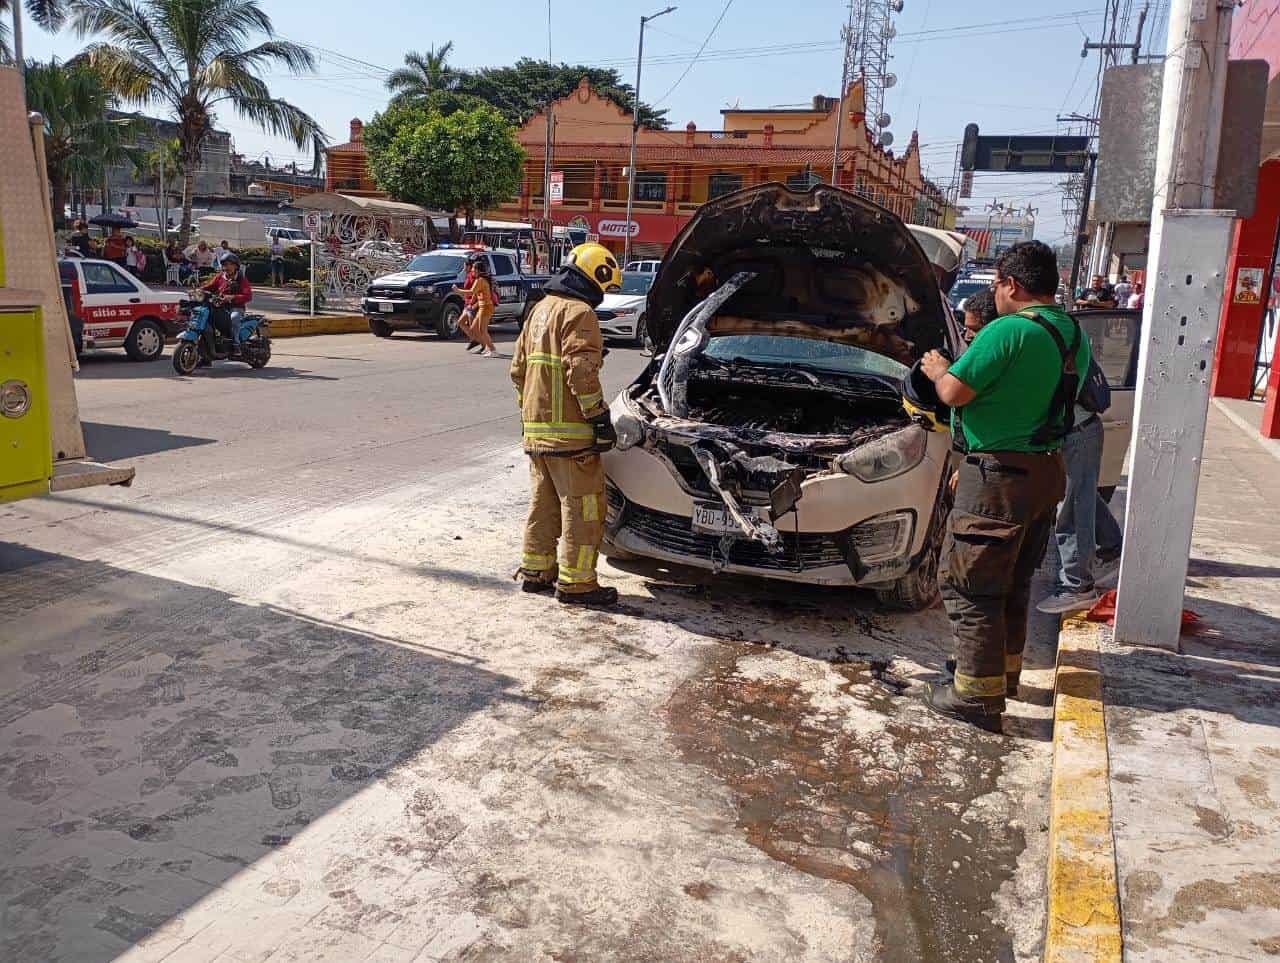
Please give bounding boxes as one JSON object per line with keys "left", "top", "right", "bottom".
{"left": 603, "top": 184, "right": 960, "bottom": 608}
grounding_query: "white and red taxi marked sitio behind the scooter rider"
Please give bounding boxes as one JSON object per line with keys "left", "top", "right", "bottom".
{"left": 58, "top": 257, "right": 187, "bottom": 361}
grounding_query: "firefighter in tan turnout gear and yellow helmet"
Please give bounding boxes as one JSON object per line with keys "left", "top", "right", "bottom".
{"left": 511, "top": 242, "right": 622, "bottom": 606}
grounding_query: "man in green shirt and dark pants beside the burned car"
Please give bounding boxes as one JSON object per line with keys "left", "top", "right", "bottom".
{"left": 922, "top": 241, "right": 1089, "bottom": 731}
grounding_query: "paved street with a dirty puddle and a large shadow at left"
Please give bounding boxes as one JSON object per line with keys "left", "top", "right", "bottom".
{"left": 0, "top": 330, "right": 1051, "bottom": 962}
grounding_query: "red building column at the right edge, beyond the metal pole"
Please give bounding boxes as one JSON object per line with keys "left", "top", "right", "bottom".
{"left": 1211, "top": 160, "right": 1280, "bottom": 398}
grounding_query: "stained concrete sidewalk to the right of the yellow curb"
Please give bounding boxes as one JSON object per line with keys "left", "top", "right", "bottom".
{"left": 1100, "top": 407, "right": 1280, "bottom": 962}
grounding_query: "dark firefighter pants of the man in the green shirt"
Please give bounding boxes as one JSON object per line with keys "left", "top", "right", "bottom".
{"left": 942, "top": 452, "right": 1066, "bottom": 711}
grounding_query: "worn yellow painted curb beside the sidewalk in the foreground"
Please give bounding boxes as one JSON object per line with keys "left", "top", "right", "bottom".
{"left": 1044, "top": 617, "right": 1123, "bottom": 963}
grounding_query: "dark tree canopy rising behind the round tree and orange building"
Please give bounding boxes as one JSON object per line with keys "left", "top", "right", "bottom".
{"left": 454, "top": 56, "right": 667, "bottom": 131}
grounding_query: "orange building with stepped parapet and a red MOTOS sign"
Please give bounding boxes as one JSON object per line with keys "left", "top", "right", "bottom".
{"left": 328, "top": 78, "right": 948, "bottom": 257}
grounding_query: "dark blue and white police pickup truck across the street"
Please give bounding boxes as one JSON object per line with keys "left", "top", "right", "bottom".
{"left": 360, "top": 245, "right": 549, "bottom": 338}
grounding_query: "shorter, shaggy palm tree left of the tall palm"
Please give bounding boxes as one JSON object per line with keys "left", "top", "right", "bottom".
{"left": 24, "top": 60, "right": 138, "bottom": 229}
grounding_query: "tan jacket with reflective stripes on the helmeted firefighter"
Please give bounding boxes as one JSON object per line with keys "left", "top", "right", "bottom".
{"left": 511, "top": 293, "right": 605, "bottom": 452}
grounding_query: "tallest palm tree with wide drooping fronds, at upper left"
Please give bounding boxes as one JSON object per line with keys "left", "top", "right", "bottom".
{"left": 68, "top": 0, "right": 328, "bottom": 245}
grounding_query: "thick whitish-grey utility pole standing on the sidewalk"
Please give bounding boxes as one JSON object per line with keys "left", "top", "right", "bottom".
{"left": 1115, "top": 0, "right": 1235, "bottom": 649}
